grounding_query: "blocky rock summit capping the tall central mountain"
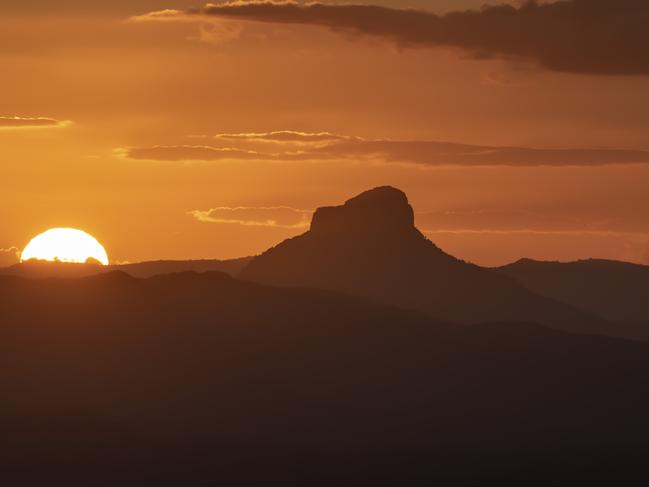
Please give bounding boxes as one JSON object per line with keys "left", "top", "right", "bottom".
{"left": 311, "top": 186, "right": 415, "bottom": 233}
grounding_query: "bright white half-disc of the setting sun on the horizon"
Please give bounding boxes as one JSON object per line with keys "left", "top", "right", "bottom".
{"left": 20, "top": 228, "right": 108, "bottom": 265}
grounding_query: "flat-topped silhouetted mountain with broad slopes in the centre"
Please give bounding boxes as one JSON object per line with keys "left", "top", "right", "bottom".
{"left": 240, "top": 187, "right": 618, "bottom": 336}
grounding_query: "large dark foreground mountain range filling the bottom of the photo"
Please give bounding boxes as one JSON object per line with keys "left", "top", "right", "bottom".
{"left": 0, "top": 272, "right": 649, "bottom": 487}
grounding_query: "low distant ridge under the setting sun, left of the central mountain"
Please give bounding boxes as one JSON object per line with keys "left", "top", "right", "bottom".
{"left": 0, "top": 257, "right": 250, "bottom": 278}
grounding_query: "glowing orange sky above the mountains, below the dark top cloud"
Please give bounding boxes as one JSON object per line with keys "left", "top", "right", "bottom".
{"left": 0, "top": 0, "right": 649, "bottom": 265}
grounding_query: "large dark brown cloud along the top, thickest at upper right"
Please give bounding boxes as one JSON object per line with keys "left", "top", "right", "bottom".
{"left": 138, "top": 0, "right": 649, "bottom": 75}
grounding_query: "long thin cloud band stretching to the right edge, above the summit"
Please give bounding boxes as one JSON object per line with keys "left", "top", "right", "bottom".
{"left": 118, "top": 131, "right": 649, "bottom": 167}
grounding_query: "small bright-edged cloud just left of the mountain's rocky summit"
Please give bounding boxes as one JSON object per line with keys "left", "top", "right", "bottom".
{"left": 189, "top": 206, "right": 313, "bottom": 229}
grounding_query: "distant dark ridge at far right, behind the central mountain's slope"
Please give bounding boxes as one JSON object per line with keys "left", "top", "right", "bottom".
{"left": 496, "top": 259, "right": 649, "bottom": 338}
